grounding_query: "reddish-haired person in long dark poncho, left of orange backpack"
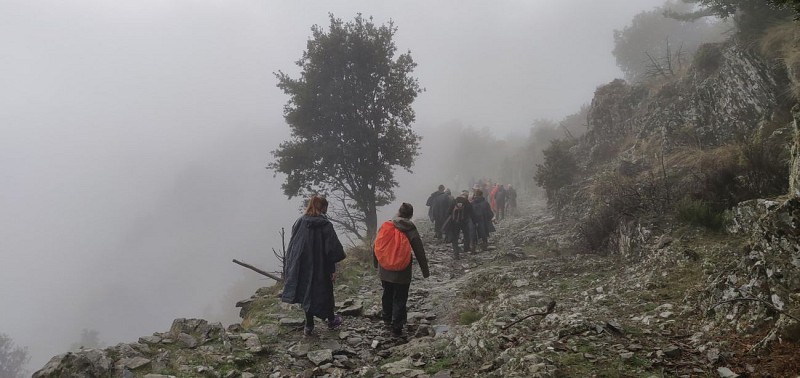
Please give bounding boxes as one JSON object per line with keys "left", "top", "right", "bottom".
{"left": 281, "top": 195, "right": 345, "bottom": 336}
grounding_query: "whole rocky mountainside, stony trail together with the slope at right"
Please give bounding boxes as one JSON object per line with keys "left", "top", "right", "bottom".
{"left": 34, "top": 36, "right": 800, "bottom": 378}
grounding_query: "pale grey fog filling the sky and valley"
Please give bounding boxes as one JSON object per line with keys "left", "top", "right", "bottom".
{"left": 0, "top": 0, "right": 661, "bottom": 370}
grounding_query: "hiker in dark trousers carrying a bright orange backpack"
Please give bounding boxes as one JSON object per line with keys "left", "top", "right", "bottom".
{"left": 373, "top": 203, "right": 430, "bottom": 336}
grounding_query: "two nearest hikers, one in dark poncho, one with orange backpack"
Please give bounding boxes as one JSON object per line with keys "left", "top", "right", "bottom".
{"left": 281, "top": 195, "right": 430, "bottom": 337}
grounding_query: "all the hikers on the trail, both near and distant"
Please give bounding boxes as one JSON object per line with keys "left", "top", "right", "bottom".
{"left": 281, "top": 185, "right": 517, "bottom": 337}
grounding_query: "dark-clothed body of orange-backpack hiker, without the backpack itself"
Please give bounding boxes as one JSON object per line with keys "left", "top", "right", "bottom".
{"left": 373, "top": 203, "right": 430, "bottom": 336}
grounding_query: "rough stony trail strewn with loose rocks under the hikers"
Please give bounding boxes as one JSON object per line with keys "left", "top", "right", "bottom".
{"left": 34, "top": 199, "right": 796, "bottom": 378}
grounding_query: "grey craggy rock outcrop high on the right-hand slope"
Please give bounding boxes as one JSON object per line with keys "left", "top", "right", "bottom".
{"left": 577, "top": 43, "right": 788, "bottom": 159}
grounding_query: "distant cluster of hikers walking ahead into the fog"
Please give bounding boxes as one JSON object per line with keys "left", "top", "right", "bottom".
{"left": 425, "top": 179, "right": 517, "bottom": 260}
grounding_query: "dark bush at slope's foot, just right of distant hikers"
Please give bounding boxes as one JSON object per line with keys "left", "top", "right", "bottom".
{"left": 534, "top": 139, "right": 578, "bottom": 201}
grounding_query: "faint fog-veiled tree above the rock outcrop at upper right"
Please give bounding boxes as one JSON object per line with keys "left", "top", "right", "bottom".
{"left": 612, "top": 1, "right": 726, "bottom": 81}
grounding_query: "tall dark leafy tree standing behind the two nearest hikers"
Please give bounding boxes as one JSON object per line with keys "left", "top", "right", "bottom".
{"left": 269, "top": 14, "right": 422, "bottom": 236}
